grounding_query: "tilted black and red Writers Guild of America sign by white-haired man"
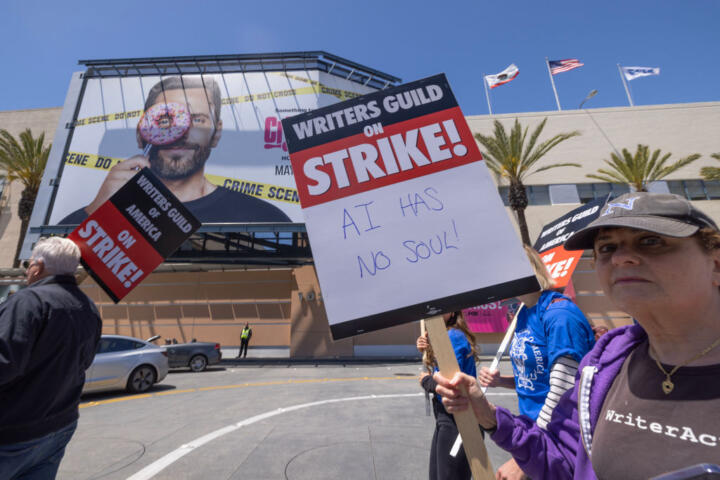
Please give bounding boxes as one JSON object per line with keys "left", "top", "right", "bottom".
{"left": 68, "top": 168, "right": 200, "bottom": 303}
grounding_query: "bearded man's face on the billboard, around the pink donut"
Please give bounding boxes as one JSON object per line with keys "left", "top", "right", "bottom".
{"left": 138, "top": 88, "right": 222, "bottom": 180}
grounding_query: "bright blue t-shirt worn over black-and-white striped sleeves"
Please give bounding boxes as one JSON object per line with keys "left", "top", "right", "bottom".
{"left": 510, "top": 290, "right": 595, "bottom": 420}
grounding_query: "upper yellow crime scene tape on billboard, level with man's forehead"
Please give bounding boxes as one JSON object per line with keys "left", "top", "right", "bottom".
{"left": 73, "top": 74, "right": 362, "bottom": 127}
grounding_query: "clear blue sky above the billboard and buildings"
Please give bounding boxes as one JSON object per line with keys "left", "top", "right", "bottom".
{"left": 0, "top": 0, "right": 720, "bottom": 115}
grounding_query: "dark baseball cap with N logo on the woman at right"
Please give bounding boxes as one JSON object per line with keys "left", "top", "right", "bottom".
{"left": 565, "top": 192, "right": 718, "bottom": 250}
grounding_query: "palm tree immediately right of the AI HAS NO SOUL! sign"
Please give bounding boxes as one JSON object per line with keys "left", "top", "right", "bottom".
{"left": 475, "top": 118, "right": 580, "bottom": 245}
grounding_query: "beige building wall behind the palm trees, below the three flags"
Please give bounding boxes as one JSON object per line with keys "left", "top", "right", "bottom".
{"left": 466, "top": 102, "right": 720, "bottom": 239}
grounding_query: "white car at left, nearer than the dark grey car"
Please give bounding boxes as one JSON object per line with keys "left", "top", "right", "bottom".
{"left": 83, "top": 335, "right": 168, "bottom": 393}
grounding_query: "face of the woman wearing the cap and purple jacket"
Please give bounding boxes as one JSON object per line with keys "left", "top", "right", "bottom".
{"left": 594, "top": 228, "right": 720, "bottom": 318}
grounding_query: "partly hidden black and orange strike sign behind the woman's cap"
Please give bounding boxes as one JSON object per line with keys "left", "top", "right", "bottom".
{"left": 534, "top": 197, "right": 607, "bottom": 288}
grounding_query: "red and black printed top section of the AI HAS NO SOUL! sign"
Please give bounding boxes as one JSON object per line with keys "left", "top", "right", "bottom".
{"left": 282, "top": 74, "right": 482, "bottom": 208}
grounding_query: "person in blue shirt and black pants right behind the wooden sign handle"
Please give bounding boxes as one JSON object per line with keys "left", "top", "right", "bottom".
{"left": 416, "top": 312, "right": 477, "bottom": 480}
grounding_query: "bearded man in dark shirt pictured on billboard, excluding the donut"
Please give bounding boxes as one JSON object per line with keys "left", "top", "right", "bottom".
{"left": 58, "top": 77, "right": 290, "bottom": 224}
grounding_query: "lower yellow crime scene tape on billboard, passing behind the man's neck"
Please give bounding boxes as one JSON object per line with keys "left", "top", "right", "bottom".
{"left": 65, "top": 152, "right": 300, "bottom": 204}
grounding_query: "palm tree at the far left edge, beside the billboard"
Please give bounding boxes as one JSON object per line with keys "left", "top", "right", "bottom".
{"left": 0, "top": 128, "right": 51, "bottom": 267}
